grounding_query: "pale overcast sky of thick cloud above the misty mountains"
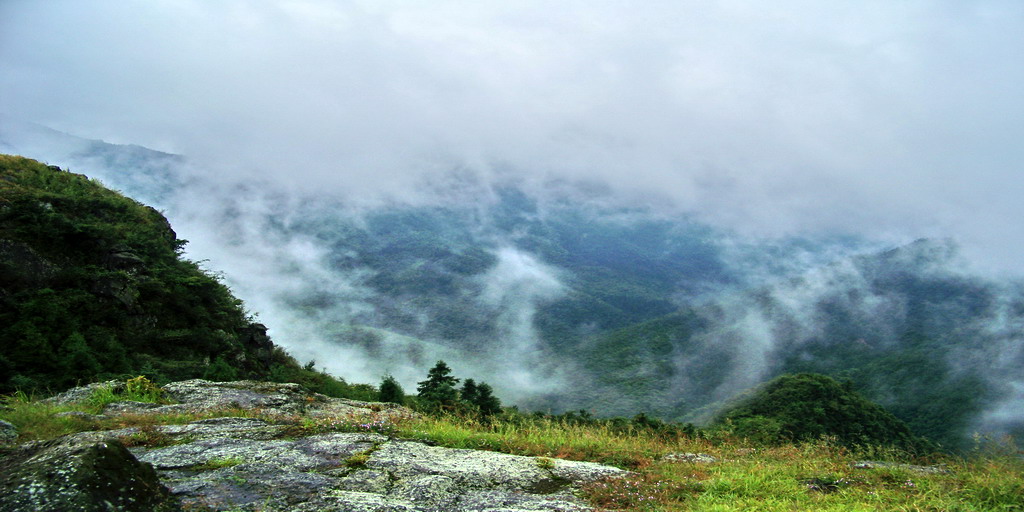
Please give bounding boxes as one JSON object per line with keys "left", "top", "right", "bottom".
{"left": 0, "top": 0, "right": 1024, "bottom": 273}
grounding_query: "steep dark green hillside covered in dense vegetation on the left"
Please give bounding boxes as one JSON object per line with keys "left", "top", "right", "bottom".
{"left": 0, "top": 156, "right": 372, "bottom": 395}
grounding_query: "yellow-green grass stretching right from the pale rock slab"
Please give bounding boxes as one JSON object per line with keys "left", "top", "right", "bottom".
{"left": 385, "top": 417, "right": 1024, "bottom": 511}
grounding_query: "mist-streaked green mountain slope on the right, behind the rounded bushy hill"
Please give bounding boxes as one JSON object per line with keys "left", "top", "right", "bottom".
{"left": 577, "top": 236, "right": 1024, "bottom": 446}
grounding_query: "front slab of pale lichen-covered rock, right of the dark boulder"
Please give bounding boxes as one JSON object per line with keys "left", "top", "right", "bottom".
{"left": 122, "top": 418, "right": 624, "bottom": 511}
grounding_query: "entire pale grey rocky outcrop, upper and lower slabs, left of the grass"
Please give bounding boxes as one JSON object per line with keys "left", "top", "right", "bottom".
{"left": 0, "top": 380, "right": 626, "bottom": 512}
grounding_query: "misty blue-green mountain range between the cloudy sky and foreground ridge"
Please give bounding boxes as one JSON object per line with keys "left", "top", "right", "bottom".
{"left": 0, "top": 121, "right": 1024, "bottom": 446}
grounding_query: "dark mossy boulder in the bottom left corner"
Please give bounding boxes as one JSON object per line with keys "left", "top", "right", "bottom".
{"left": 0, "top": 436, "right": 180, "bottom": 512}
